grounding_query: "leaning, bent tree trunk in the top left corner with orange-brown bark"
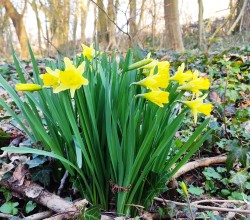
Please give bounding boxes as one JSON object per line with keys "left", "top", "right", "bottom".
{"left": 0, "top": 0, "right": 29, "bottom": 58}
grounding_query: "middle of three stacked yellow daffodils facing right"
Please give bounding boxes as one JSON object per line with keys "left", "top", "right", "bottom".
{"left": 132, "top": 74, "right": 169, "bottom": 90}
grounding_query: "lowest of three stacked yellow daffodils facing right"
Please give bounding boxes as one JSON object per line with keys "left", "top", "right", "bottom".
{"left": 136, "top": 90, "right": 169, "bottom": 107}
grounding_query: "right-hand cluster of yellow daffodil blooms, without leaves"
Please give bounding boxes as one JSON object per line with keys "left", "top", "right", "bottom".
{"left": 129, "top": 60, "right": 212, "bottom": 124}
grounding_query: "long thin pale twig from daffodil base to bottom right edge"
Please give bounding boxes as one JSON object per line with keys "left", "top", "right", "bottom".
{"left": 154, "top": 197, "right": 250, "bottom": 214}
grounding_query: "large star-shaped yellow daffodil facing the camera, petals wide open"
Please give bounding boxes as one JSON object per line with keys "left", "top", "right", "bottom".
{"left": 54, "top": 58, "right": 89, "bottom": 98}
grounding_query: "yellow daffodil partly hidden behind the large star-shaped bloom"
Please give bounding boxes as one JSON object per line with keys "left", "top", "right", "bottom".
{"left": 40, "top": 67, "right": 60, "bottom": 89}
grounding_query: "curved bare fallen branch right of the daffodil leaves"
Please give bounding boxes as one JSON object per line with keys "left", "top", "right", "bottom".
{"left": 172, "top": 156, "right": 227, "bottom": 179}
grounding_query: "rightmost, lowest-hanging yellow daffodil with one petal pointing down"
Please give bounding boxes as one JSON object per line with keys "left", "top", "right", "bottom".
{"left": 180, "top": 94, "right": 213, "bottom": 124}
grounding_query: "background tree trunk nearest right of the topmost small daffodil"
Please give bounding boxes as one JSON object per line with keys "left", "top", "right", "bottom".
{"left": 97, "top": 0, "right": 109, "bottom": 48}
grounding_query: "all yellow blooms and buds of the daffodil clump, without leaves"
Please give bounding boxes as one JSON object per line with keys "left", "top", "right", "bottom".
{"left": 16, "top": 44, "right": 212, "bottom": 124}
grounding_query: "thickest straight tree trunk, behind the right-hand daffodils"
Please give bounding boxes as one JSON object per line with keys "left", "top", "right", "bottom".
{"left": 164, "top": 0, "right": 184, "bottom": 52}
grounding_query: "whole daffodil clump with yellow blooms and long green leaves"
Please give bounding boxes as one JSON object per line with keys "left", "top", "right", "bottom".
{"left": 0, "top": 43, "right": 215, "bottom": 216}
